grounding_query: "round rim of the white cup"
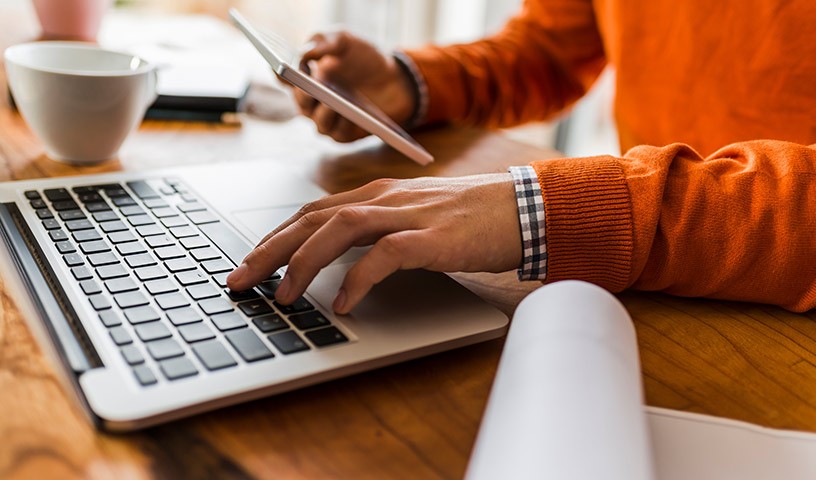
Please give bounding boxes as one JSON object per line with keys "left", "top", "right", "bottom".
{"left": 4, "top": 41, "right": 156, "bottom": 77}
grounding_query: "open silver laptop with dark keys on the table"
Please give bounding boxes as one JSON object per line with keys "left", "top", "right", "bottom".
{"left": 0, "top": 161, "right": 507, "bottom": 430}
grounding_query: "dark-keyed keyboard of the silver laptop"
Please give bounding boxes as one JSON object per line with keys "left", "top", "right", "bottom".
{"left": 25, "top": 179, "right": 349, "bottom": 386}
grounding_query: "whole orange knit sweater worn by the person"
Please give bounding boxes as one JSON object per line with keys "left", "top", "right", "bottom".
{"left": 408, "top": 0, "right": 816, "bottom": 311}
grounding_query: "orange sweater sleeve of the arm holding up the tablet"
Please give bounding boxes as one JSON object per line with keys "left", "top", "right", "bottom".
{"left": 406, "top": 0, "right": 605, "bottom": 127}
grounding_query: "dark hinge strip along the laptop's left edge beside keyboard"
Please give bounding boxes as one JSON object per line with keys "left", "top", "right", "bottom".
{"left": 0, "top": 203, "right": 103, "bottom": 374}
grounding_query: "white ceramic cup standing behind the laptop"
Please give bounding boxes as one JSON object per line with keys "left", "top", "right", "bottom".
{"left": 5, "top": 42, "right": 156, "bottom": 164}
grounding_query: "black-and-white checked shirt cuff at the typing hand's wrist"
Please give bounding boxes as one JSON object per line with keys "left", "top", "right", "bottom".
{"left": 509, "top": 167, "right": 547, "bottom": 280}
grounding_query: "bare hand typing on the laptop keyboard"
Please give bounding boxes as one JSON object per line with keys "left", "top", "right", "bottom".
{"left": 227, "top": 174, "right": 521, "bottom": 314}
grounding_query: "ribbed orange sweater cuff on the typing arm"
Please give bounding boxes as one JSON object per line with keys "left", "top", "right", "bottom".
{"left": 531, "top": 157, "right": 634, "bottom": 291}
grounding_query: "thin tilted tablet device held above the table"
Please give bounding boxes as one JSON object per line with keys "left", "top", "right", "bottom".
{"left": 229, "top": 8, "right": 433, "bottom": 165}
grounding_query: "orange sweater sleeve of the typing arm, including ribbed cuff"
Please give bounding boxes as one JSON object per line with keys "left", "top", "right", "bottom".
{"left": 532, "top": 140, "right": 816, "bottom": 311}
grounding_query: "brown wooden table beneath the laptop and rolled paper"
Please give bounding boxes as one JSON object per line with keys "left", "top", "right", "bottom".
{"left": 0, "top": 6, "right": 816, "bottom": 479}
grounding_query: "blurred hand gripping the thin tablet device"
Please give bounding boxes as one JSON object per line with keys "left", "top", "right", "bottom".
{"left": 294, "top": 32, "right": 414, "bottom": 142}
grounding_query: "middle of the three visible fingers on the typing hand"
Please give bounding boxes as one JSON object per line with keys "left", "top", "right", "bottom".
{"left": 276, "top": 206, "right": 416, "bottom": 304}
